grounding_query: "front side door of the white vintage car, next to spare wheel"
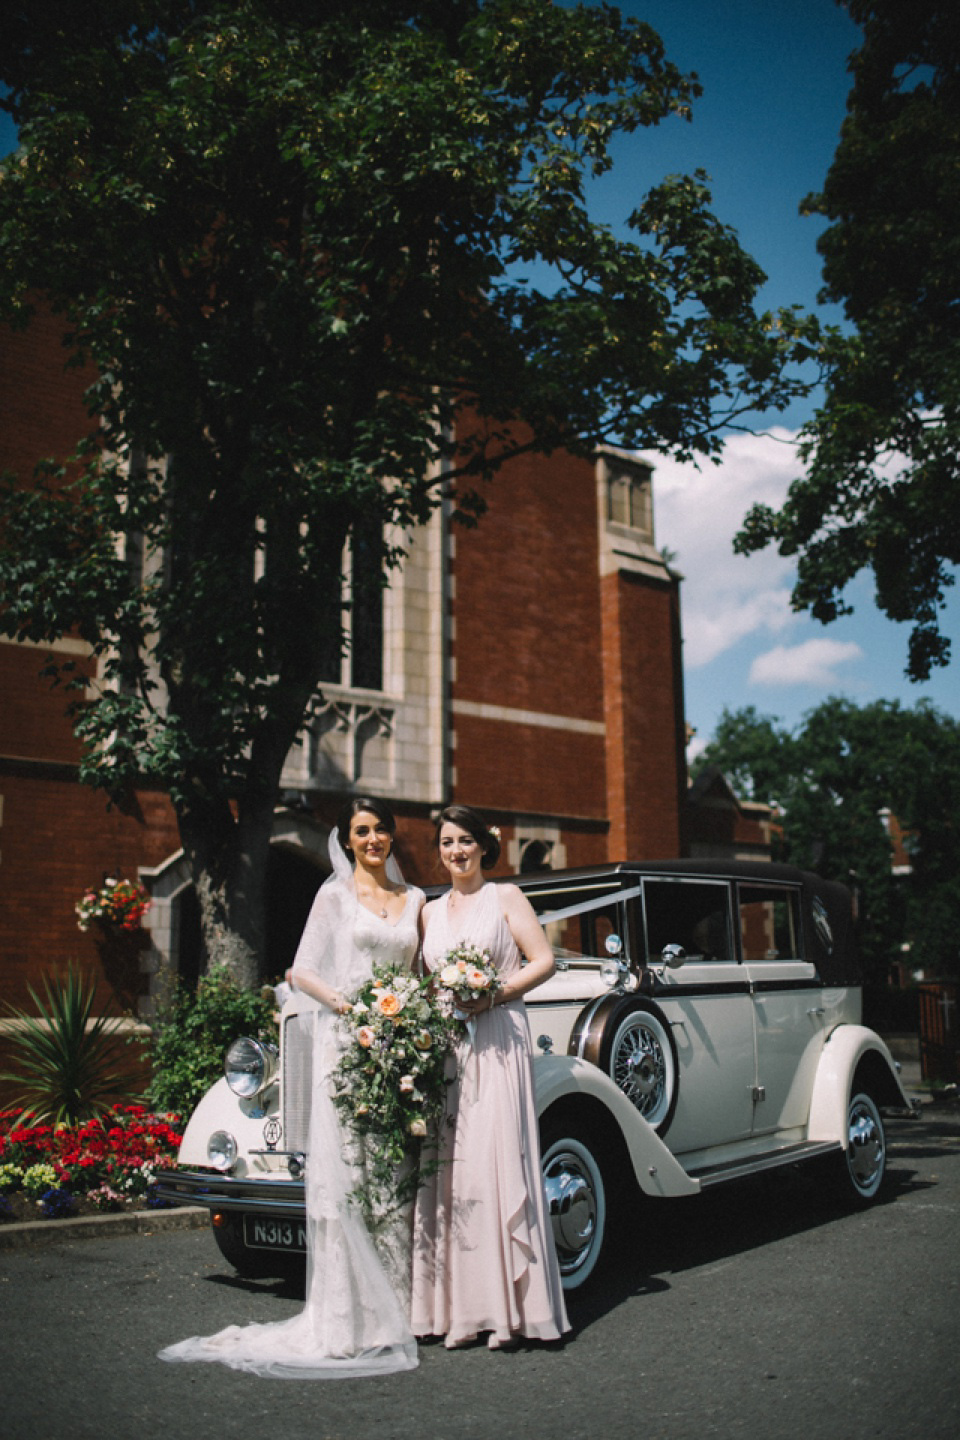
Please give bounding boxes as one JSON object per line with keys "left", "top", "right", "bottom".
{"left": 642, "top": 876, "right": 754, "bottom": 1155}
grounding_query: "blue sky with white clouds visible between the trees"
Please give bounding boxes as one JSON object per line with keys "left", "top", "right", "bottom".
{"left": 0, "top": 8, "right": 960, "bottom": 749}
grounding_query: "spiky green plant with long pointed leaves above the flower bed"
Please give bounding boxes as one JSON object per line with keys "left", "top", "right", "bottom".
{"left": 0, "top": 965, "right": 132, "bottom": 1125}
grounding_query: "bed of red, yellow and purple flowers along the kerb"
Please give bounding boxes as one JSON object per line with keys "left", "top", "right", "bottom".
{"left": 0, "top": 1106, "right": 181, "bottom": 1223}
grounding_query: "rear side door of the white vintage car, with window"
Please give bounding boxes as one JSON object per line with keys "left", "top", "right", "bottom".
{"left": 737, "top": 881, "right": 826, "bottom": 1135}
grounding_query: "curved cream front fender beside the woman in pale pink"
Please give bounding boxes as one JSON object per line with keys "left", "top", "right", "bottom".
{"left": 534, "top": 1056, "right": 699, "bottom": 1197}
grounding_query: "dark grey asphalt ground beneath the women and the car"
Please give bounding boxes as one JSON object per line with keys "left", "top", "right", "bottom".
{"left": 0, "top": 1106, "right": 960, "bottom": 1440}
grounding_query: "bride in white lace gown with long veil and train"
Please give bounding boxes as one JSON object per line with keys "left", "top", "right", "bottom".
{"left": 160, "top": 796, "right": 423, "bottom": 1380}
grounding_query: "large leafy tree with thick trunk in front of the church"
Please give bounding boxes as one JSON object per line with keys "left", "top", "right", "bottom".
{"left": 0, "top": 0, "right": 817, "bottom": 981}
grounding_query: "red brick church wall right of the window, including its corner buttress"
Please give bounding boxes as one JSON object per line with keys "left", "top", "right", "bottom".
{"left": 450, "top": 432, "right": 685, "bottom": 864}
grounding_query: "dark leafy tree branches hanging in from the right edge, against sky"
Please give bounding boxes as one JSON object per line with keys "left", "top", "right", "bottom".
{"left": 735, "top": 0, "right": 960, "bottom": 680}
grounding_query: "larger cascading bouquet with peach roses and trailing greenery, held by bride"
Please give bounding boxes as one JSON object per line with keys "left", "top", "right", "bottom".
{"left": 332, "top": 966, "right": 453, "bottom": 1214}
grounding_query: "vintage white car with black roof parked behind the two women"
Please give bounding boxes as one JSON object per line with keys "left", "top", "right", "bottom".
{"left": 160, "top": 860, "right": 914, "bottom": 1290}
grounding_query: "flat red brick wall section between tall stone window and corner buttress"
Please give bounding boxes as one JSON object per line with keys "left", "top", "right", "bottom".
{"left": 452, "top": 440, "right": 604, "bottom": 818}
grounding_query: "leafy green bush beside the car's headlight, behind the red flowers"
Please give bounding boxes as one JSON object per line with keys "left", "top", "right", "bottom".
{"left": 148, "top": 965, "right": 276, "bottom": 1116}
